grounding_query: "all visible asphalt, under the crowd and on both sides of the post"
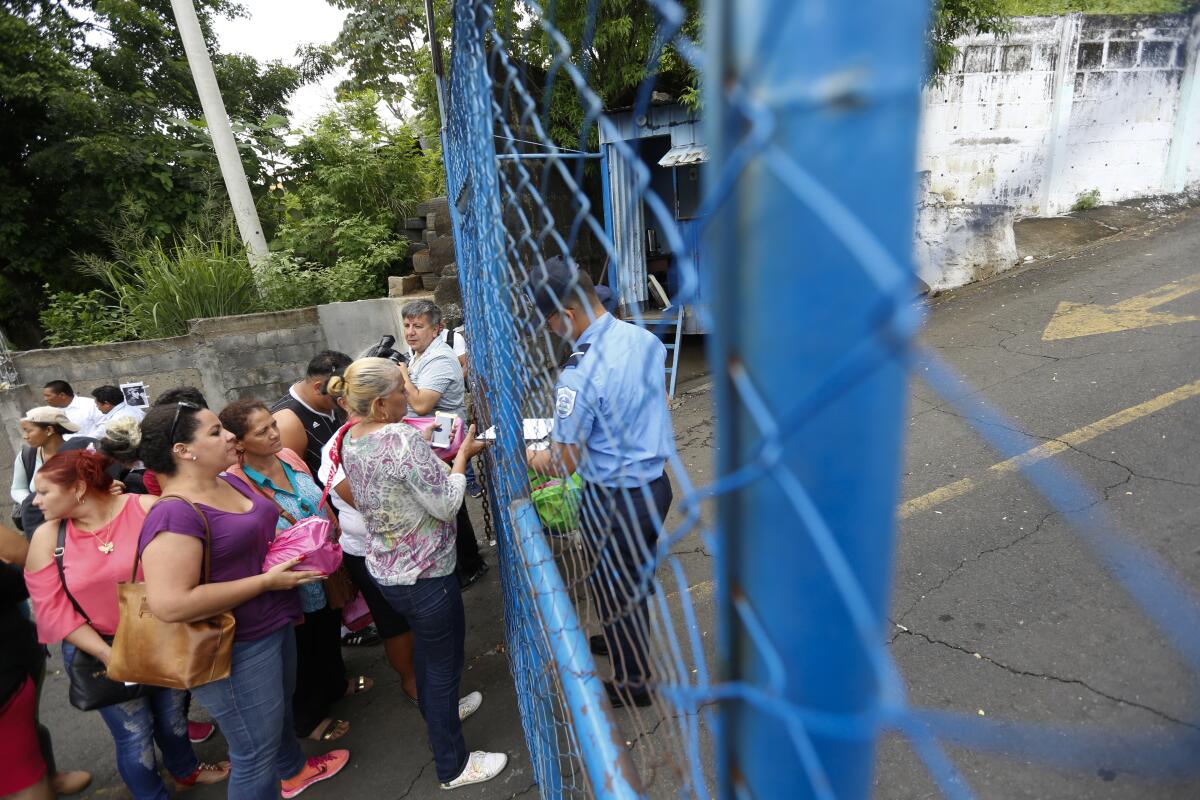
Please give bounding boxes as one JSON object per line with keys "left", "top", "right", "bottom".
{"left": 32, "top": 210, "right": 1200, "bottom": 800}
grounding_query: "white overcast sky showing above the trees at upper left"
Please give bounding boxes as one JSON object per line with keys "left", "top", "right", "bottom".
{"left": 216, "top": 0, "right": 346, "bottom": 126}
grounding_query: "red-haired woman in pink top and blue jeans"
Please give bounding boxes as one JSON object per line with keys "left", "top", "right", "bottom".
{"left": 25, "top": 450, "right": 229, "bottom": 800}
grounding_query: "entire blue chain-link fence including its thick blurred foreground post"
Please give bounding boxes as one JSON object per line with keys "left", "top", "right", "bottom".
{"left": 443, "top": 0, "right": 1200, "bottom": 798}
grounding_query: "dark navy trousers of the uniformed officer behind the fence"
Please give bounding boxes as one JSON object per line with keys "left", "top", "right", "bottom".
{"left": 580, "top": 475, "right": 672, "bottom": 692}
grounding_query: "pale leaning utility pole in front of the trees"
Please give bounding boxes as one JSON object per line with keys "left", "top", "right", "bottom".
{"left": 170, "top": 0, "right": 268, "bottom": 264}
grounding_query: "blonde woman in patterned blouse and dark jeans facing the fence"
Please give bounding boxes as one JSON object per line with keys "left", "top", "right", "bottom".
{"left": 329, "top": 359, "right": 508, "bottom": 789}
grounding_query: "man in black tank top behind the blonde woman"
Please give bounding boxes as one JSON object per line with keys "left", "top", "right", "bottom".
{"left": 271, "top": 350, "right": 350, "bottom": 488}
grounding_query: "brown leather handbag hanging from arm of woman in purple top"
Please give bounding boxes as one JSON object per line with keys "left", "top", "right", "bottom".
{"left": 108, "top": 494, "right": 234, "bottom": 688}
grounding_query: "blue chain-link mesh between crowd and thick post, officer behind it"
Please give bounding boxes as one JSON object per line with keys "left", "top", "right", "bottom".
{"left": 445, "top": 2, "right": 713, "bottom": 796}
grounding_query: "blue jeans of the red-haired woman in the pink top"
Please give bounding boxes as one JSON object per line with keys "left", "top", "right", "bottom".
{"left": 62, "top": 643, "right": 199, "bottom": 800}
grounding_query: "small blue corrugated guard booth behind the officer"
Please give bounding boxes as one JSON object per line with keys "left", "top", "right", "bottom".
{"left": 600, "top": 102, "right": 708, "bottom": 333}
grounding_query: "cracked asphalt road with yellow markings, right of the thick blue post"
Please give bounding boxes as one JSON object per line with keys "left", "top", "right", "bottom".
{"left": 875, "top": 203, "right": 1200, "bottom": 798}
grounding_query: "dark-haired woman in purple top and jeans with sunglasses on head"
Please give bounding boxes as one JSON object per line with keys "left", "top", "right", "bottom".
{"left": 138, "top": 403, "right": 349, "bottom": 800}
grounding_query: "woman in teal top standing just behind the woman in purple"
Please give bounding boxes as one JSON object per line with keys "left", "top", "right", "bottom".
{"left": 218, "top": 399, "right": 373, "bottom": 741}
